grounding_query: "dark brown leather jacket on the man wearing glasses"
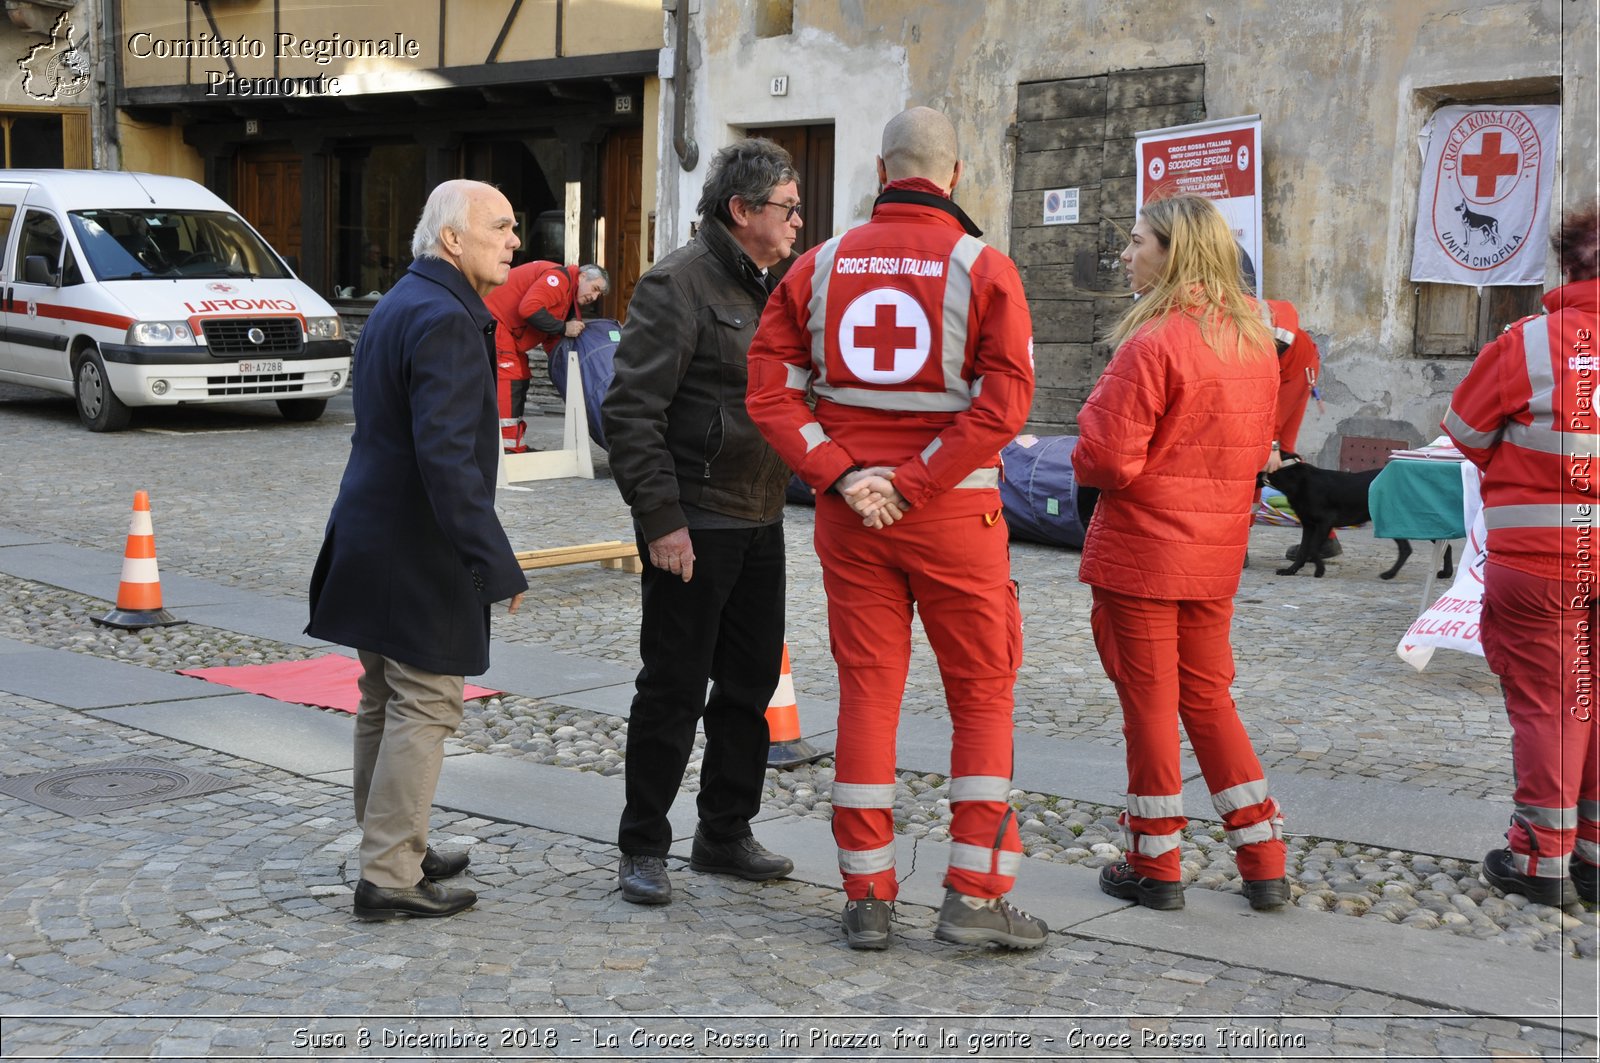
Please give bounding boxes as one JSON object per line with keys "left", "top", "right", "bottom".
{"left": 602, "top": 218, "right": 789, "bottom": 541}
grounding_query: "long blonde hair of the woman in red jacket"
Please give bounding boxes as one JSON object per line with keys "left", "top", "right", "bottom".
{"left": 1107, "top": 195, "right": 1274, "bottom": 362}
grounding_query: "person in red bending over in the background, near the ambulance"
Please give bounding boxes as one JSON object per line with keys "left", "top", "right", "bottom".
{"left": 483, "top": 263, "right": 610, "bottom": 453}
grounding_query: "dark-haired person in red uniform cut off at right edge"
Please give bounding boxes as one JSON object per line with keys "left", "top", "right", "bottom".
{"left": 1442, "top": 207, "right": 1600, "bottom": 905}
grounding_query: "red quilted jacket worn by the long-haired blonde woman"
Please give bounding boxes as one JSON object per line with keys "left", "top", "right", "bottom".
{"left": 1072, "top": 314, "right": 1278, "bottom": 600}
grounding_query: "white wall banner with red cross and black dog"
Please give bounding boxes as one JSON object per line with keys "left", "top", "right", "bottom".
{"left": 1411, "top": 104, "right": 1562, "bottom": 287}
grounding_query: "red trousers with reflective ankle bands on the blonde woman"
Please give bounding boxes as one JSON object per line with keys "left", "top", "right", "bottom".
{"left": 1090, "top": 588, "right": 1285, "bottom": 882}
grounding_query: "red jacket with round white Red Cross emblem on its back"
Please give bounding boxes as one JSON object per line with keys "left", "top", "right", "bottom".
{"left": 747, "top": 191, "right": 1034, "bottom": 519}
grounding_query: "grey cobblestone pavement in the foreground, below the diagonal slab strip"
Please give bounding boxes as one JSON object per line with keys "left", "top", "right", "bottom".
{"left": 0, "top": 696, "right": 1594, "bottom": 1060}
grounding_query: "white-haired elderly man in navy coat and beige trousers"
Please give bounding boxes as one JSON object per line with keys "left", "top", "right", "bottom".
{"left": 306, "top": 181, "right": 528, "bottom": 919}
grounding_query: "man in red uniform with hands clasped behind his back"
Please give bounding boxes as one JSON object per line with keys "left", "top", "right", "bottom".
{"left": 747, "top": 107, "right": 1048, "bottom": 949}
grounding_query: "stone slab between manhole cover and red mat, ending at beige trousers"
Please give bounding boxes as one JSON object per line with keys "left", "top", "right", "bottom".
{"left": 94, "top": 688, "right": 355, "bottom": 775}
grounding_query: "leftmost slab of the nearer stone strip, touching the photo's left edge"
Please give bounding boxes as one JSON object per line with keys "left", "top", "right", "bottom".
{"left": 0, "top": 648, "right": 227, "bottom": 709}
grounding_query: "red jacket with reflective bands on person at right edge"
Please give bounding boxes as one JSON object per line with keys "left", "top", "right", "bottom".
{"left": 1442, "top": 273, "right": 1600, "bottom": 573}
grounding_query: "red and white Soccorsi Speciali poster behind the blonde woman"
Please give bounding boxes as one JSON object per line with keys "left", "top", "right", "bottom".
{"left": 1133, "top": 115, "right": 1266, "bottom": 291}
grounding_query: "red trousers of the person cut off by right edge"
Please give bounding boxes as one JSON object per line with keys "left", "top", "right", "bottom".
{"left": 1480, "top": 556, "right": 1600, "bottom": 879}
